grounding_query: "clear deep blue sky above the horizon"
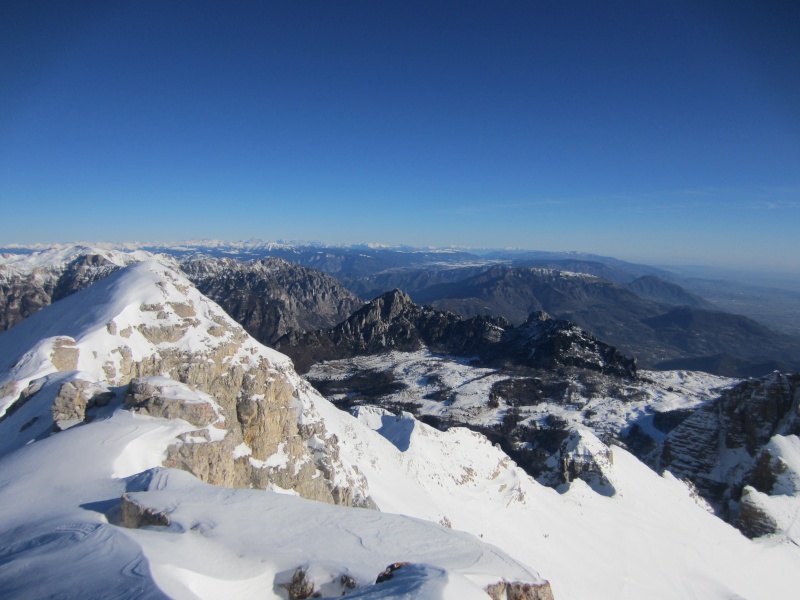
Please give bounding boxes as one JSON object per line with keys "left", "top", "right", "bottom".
{"left": 0, "top": 0, "right": 800, "bottom": 269}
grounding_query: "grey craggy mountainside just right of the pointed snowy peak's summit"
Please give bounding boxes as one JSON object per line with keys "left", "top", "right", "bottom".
{"left": 181, "top": 257, "right": 363, "bottom": 345}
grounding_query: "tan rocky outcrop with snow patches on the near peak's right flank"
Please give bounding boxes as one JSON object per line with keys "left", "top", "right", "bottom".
{"left": 112, "top": 332, "right": 370, "bottom": 505}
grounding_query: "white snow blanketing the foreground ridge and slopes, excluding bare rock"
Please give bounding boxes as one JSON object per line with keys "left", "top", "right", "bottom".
{"left": 0, "top": 255, "right": 800, "bottom": 600}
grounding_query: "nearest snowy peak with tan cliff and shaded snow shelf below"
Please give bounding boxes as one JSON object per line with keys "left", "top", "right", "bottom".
{"left": 0, "top": 261, "right": 549, "bottom": 598}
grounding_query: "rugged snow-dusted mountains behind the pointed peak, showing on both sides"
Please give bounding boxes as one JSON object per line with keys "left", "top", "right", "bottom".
{"left": 0, "top": 244, "right": 363, "bottom": 343}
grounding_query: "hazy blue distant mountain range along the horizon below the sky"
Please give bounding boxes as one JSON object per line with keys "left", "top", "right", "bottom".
{"left": 0, "top": 242, "right": 800, "bottom": 376}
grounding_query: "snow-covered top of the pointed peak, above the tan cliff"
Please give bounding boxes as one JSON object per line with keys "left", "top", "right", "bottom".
{"left": 0, "top": 259, "right": 288, "bottom": 398}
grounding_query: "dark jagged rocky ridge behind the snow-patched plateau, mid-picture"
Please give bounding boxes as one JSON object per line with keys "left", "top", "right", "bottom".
{"left": 276, "top": 290, "right": 636, "bottom": 378}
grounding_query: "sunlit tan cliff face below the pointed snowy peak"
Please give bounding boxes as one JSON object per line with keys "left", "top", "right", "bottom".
{"left": 119, "top": 376, "right": 346, "bottom": 505}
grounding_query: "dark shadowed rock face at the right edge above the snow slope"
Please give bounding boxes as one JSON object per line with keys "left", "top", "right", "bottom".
{"left": 660, "top": 372, "right": 800, "bottom": 535}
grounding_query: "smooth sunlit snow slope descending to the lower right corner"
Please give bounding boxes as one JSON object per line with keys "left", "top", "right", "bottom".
{"left": 310, "top": 403, "right": 800, "bottom": 600}
